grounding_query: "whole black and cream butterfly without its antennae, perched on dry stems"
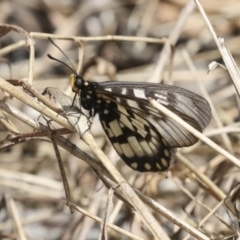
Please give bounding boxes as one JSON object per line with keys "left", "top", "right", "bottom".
{"left": 71, "top": 75, "right": 211, "bottom": 172}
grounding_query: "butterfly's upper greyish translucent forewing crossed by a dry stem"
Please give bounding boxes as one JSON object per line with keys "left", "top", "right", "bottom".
{"left": 98, "top": 82, "right": 211, "bottom": 147}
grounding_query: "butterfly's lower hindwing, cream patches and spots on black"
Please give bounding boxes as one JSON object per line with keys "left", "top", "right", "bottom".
{"left": 99, "top": 100, "right": 176, "bottom": 172}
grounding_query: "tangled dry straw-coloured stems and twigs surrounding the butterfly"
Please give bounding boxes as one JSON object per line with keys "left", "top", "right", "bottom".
{"left": 0, "top": 0, "right": 240, "bottom": 240}
